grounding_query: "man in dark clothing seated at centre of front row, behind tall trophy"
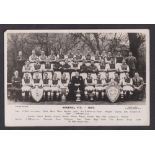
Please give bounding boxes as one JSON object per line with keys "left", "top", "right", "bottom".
{"left": 69, "top": 71, "right": 84, "bottom": 100}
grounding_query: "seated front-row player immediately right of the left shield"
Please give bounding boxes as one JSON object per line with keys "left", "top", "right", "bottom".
{"left": 43, "top": 72, "right": 51, "bottom": 100}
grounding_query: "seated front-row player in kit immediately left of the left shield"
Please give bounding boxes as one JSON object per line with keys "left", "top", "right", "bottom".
{"left": 22, "top": 73, "right": 32, "bottom": 100}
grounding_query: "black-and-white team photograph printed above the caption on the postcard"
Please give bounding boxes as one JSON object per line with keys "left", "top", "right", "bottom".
{"left": 6, "top": 31, "right": 147, "bottom": 105}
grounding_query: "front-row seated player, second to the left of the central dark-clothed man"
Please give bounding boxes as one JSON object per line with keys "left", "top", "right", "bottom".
{"left": 51, "top": 73, "right": 60, "bottom": 100}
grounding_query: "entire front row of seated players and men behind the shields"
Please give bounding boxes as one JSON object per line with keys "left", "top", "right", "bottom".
{"left": 9, "top": 68, "right": 144, "bottom": 100}
